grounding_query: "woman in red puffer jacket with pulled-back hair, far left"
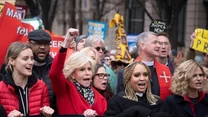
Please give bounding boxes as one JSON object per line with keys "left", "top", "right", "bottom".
{"left": 0, "top": 42, "right": 54, "bottom": 117}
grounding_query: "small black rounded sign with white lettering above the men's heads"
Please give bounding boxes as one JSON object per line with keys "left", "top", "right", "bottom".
{"left": 149, "top": 20, "right": 167, "bottom": 33}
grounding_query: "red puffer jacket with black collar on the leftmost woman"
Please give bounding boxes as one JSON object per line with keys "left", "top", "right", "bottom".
{"left": 0, "top": 73, "right": 49, "bottom": 115}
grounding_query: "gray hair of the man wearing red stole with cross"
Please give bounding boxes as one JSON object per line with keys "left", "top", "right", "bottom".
{"left": 136, "top": 31, "right": 157, "bottom": 50}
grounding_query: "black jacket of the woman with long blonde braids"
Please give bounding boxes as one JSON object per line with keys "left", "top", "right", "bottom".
{"left": 104, "top": 92, "right": 171, "bottom": 117}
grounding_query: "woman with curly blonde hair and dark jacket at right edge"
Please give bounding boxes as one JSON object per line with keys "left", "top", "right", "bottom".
{"left": 166, "top": 60, "right": 208, "bottom": 117}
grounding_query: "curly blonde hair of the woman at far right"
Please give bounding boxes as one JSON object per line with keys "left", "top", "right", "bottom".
{"left": 170, "top": 60, "right": 208, "bottom": 96}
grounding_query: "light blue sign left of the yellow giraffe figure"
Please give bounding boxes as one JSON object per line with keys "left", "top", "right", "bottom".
{"left": 87, "top": 20, "right": 107, "bottom": 40}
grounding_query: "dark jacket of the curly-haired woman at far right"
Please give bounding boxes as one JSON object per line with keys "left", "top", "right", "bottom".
{"left": 166, "top": 94, "right": 208, "bottom": 117}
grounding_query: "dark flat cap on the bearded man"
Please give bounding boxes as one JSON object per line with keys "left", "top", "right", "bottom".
{"left": 28, "top": 30, "right": 51, "bottom": 42}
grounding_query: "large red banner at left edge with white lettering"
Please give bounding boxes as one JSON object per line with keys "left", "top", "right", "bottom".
{"left": 0, "top": 2, "right": 34, "bottom": 65}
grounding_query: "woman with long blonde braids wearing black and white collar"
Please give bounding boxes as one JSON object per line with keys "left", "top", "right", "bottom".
{"left": 105, "top": 62, "right": 171, "bottom": 117}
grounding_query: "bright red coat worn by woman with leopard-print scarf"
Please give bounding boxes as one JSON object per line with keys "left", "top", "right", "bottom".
{"left": 49, "top": 53, "right": 107, "bottom": 115}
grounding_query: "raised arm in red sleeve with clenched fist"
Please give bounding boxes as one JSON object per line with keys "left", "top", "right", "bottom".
{"left": 49, "top": 28, "right": 79, "bottom": 96}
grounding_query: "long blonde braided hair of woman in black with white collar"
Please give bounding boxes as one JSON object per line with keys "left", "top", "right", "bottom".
{"left": 124, "top": 61, "right": 159, "bottom": 104}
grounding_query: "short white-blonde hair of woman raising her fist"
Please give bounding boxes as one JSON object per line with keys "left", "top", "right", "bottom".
{"left": 63, "top": 52, "right": 94, "bottom": 81}
